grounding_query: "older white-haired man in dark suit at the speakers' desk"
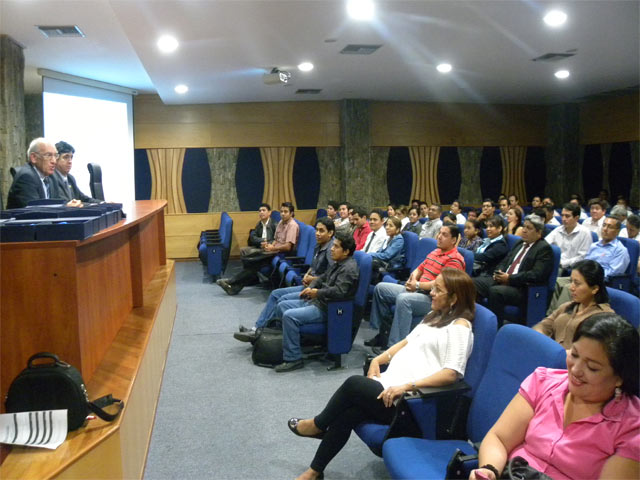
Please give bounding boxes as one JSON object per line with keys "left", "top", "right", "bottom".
{"left": 7, "top": 138, "right": 60, "bottom": 209}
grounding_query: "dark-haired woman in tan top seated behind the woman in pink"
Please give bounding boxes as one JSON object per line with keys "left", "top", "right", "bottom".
{"left": 533, "top": 260, "right": 613, "bottom": 350}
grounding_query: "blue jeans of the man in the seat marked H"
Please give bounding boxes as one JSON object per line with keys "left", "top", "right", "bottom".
{"left": 275, "top": 299, "right": 327, "bottom": 362}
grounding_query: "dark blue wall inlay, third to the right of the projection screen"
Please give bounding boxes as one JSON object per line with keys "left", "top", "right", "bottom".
{"left": 236, "top": 147, "right": 264, "bottom": 211}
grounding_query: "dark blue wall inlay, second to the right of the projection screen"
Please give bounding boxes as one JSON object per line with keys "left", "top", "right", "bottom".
{"left": 182, "top": 148, "right": 211, "bottom": 213}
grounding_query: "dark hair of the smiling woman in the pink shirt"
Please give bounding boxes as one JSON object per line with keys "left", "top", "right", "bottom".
{"left": 573, "top": 312, "right": 640, "bottom": 396}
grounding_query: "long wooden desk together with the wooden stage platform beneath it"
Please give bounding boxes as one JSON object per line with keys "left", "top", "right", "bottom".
{"left": 0, "top": 200, "right": 176, "bottom": 478}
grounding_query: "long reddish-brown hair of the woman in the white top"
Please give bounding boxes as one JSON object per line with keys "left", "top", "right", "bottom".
{"left": 423, "top": 267, "right": 476, "bottom": 328}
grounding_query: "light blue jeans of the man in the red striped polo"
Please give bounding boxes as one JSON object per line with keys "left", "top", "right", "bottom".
{"left": 369, "top": 283, "right": 431, "bottom": 345}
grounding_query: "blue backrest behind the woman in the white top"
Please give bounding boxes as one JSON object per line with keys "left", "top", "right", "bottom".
{"left": 464, "top": 303, "right": 498, "bottom": 398}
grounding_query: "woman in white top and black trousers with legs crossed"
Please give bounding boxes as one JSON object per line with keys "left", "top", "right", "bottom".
{"left": 288, "top": 268, "right": 475, "bottom": 480}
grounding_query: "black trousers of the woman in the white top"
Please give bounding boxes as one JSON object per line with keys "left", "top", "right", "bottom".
{"left": 311, "top": 375, "right": 395, "bottom": 472}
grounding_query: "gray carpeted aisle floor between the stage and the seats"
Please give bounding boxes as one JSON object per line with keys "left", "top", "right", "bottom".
{"left": 145, "top": 262, "right": 389, "bottom": 480}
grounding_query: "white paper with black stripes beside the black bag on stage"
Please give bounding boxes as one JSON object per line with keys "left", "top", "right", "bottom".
{"left": 0, "top": 410, "right": 67, "bottom": 450}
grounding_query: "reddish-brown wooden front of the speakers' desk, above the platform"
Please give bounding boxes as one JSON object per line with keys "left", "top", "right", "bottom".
{"left": 0, "top": 200, "right": 166, "bottom": 408}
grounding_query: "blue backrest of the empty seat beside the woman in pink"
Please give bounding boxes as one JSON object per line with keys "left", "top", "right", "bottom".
{"left": 467, "top": 324, "right": 566, "bottom": 442}
